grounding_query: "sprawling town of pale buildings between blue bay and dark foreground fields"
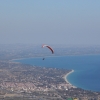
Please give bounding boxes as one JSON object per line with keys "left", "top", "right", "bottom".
{"left": 0, "top": 61, "right": 76, "bottom": 92}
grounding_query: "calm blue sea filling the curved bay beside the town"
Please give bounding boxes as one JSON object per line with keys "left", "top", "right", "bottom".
{"left": 14, "top": 55, "right": 100, "bottom": 92}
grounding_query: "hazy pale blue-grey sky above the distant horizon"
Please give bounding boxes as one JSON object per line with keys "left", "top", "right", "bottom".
{"left": 0, "top": 0, "right": 100, "bottom": 45}
